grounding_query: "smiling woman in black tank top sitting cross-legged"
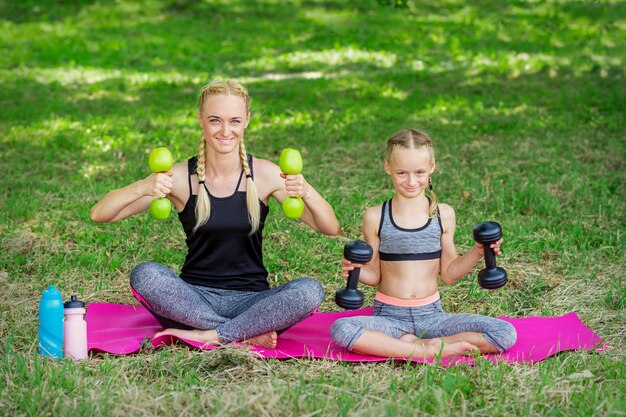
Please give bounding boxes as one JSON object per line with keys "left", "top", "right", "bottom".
{"left": 91, "top": 81, "right": 339, "bottom": 348}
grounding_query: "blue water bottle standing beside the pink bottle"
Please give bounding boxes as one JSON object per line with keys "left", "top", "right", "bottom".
{"left": 38, "top": 285, "right": 63, "bottom": 359}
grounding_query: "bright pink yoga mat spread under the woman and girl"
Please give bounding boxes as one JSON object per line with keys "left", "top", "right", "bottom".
{"left": 85, "top": 303, "right": 603, "bottom": 366}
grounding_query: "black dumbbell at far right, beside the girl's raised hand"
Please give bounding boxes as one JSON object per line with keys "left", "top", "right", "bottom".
{"left": 472, "top": 222, "right": 506, "bottom": 290}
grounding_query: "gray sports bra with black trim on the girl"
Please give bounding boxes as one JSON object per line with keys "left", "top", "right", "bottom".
{"left": 378, "top": 199, "right": 443, "bottom": 261}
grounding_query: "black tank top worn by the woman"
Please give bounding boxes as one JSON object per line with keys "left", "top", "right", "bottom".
{"left": 178, "top": 155, "right": 269, "bottom": 291}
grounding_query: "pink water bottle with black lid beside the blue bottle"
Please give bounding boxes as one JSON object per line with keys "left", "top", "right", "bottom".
{"left": 63, "top": 295, "right": 87, "bottom": 360}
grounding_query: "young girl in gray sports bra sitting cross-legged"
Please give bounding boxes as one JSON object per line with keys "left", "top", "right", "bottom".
{"left": 331, "top": 130, "right": 517, "bottom": 358}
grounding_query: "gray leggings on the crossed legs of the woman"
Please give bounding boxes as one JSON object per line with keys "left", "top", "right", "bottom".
{"left": 130, "top": 262, "right": 324, "bottom": 343}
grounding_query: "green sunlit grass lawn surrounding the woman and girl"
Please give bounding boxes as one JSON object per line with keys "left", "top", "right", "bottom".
{"left": 0, "top": 0, "right": 626, "bottom": 417}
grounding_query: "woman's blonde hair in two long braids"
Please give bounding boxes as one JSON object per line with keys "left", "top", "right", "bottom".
{"left": 193, "top": 81, "right": 261, "bottom": 234}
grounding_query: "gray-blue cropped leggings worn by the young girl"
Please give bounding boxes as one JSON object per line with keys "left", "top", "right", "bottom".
{"left": 330, "top": 300, "right": 517, "bottom": 352}
